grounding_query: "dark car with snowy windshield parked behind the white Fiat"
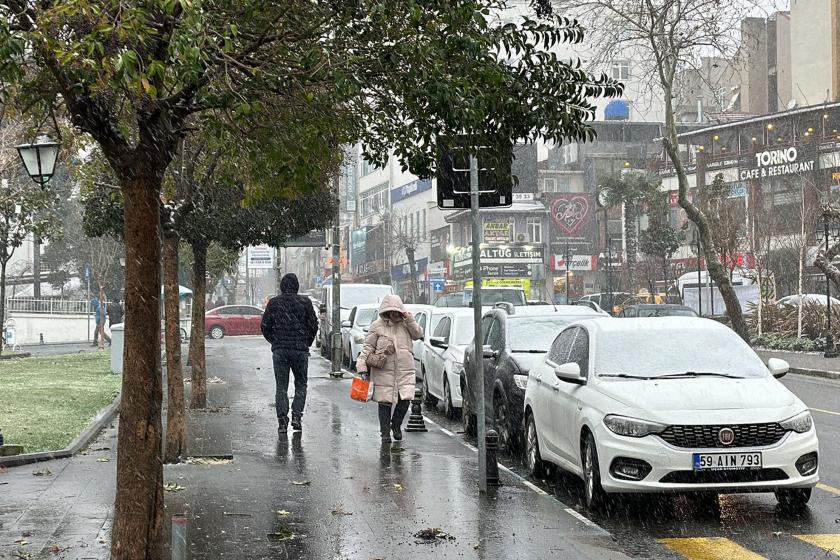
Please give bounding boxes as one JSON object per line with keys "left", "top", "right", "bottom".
{"left": 461, "top": 305, "right": 613, "bottom": 451}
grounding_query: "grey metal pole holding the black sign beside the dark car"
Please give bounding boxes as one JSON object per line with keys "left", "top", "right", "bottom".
{"left": 466, "top": 155, "right": 487, "bottom": 492}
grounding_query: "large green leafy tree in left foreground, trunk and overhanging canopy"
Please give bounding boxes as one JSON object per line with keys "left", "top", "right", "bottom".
{"left": 0, "top": 0, "right": 620, "bottom": 559}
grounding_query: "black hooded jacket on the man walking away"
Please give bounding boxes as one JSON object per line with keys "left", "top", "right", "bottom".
{"left": 261, "top": 274, "right": 318, "bottom": 351}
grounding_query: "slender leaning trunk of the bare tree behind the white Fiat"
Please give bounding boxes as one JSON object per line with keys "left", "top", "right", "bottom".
{"left": 662, "top": 135, "right": 750, "bottom": 342}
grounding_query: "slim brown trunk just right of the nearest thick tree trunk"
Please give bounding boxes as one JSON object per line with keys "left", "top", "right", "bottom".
{"left": 163, "top": 235, "right": 186, "bottom": 463}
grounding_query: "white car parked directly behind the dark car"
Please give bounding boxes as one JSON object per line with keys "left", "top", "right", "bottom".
{"left": 421, "top": 307, "right": 475, "bottom": 418}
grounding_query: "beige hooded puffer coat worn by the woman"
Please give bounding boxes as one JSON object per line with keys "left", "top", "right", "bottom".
{"left": 356, "top": 295, "right": 423, "bottom": 403}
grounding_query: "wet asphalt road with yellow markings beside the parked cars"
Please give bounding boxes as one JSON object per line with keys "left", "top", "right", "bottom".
{"left": 424, "top": 375, "right": 840, "bottom": 560}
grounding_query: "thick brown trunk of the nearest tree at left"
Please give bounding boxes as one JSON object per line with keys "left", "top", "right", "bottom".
{"left": 111, "top": 177, "right": 163, "bottom": 560}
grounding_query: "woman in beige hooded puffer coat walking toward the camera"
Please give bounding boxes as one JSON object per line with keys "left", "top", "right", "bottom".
{"left": 356, "top": 295, "right": 423, "bottom": 443}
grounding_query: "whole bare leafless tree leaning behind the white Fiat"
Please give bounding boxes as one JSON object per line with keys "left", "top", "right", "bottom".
{"left": 554, "top": 0, "right": 768, "bottom": 339}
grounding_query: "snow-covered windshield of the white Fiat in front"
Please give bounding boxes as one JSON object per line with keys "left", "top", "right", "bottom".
{"left": 595, "top": 328, "right": 768, "bottom": 378}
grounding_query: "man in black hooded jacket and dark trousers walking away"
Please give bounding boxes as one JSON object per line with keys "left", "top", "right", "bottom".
{"left": 261, "top": 274, "right": 318, "bottom": 435}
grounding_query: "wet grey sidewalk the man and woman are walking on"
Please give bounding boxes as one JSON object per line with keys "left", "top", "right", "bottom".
{"left": 0, "top": 339, "right": 627, "bottom": 560}
